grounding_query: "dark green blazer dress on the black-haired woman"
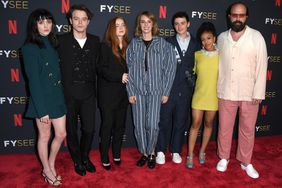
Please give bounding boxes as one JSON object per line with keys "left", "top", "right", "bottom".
{"left": 22, "top": 38, "right": 66, "bottom": 118}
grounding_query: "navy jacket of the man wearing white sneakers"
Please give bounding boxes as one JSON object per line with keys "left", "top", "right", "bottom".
{"left": 167, "top": 35, "right": 200, "bottom": 93}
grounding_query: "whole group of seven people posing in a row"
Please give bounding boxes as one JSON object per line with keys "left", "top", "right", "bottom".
{"left": 22, "top": 2, "right": 267, "bottom": 186}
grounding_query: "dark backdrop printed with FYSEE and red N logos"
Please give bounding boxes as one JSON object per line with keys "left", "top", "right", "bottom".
{"left": 0, "top": 0, "right": 282, "bottom": 153}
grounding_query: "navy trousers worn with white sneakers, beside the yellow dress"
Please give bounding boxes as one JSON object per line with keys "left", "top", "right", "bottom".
{"left": 156, "top": 89, "right": 192, "bottom": 153}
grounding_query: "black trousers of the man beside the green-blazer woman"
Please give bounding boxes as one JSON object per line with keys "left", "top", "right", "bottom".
{"left": 66, "top": 95, "right": 96, "bottom": 164}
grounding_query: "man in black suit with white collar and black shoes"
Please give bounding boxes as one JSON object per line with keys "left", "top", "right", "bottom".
{"left": 58, "top": 5, "right": 100, "bottom": 176}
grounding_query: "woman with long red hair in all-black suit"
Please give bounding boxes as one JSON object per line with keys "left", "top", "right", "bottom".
{"left": 98, "top": 17, "right": 128, "bottom": 170}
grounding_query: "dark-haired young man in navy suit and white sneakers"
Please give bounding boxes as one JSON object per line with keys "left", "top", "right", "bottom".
{"left": 156, "top": 12, "right": 200, "bottom": 164}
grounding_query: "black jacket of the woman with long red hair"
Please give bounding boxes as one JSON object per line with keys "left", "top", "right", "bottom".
{"left": 98, "top": 43, "right": 128, "bottom": 109}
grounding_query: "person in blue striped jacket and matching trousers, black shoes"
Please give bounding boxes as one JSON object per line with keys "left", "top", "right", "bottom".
{"left": 126, "top": 11, "right": 176, "bottom": 169}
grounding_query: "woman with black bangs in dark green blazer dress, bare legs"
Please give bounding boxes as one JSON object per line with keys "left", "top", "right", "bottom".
{"left": 22, "top": 9, "right": 66, "bottom": 186}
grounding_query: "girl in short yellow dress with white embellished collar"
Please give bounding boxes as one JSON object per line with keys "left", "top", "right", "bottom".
{"left": 186, "top": 22, "right": 218, "bottom": 168}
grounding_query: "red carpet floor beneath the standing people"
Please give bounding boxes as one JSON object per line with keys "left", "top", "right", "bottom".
{"left": 0, "top": 136, "right": 282, "bottom": 188}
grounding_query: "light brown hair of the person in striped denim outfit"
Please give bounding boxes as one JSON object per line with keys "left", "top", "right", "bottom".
{"left": 135, "top": 11, "right": 159, "bottom": 37}
